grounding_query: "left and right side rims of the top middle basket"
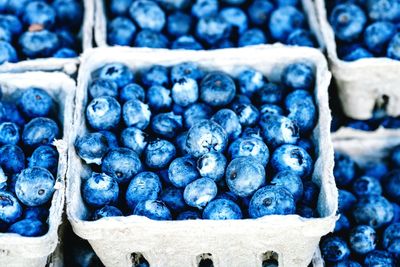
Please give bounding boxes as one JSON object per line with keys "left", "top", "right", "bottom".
{"left": 94, "top": 0, "right": 325, "bottom": 51}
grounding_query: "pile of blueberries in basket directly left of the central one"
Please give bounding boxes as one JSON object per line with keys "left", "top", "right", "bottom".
{"left": 0, "top": 88, "right": 61, "bottom": 236}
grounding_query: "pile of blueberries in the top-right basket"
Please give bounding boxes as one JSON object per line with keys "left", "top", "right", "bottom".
{"left": 326, "top": 0, "right": 400, "bottom": 61}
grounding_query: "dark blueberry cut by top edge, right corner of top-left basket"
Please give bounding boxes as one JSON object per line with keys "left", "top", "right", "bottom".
{"left": 53, "top": 0, "right": 83, "bottom": 29}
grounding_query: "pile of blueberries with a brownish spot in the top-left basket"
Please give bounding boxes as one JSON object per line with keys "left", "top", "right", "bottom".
{"left": 0, "top": 0, "right": 83, "bottom": 64}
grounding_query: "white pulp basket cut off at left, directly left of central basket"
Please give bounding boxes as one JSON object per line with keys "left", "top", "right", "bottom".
{"left": 0, "top": 72, "right": 75, "bottom": 267}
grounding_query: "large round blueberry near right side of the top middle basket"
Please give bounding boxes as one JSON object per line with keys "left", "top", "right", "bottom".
{"left": 268, "top": 6, "right": 306, "bottom": 42}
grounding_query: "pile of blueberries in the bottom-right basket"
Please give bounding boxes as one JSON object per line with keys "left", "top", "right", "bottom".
{"left": 320, "top": 150, "right": 400, "bottom": 267}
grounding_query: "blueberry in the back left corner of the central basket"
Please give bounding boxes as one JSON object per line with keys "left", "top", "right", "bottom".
{"left": 95, "top": 63, "right": 133, "bottom": 88}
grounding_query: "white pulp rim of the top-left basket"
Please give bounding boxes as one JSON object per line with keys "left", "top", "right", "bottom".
{"left": 0, "top": 0, "right": 95, "bottom": 75}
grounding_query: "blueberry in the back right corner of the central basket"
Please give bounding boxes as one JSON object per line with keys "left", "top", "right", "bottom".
{"left": 281, "top": 62, "right": 315, "bottom": 91}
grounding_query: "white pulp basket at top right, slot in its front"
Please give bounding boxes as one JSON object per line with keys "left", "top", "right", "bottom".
{"left": 315, "top": 0, "right": 400, "bottom": 120}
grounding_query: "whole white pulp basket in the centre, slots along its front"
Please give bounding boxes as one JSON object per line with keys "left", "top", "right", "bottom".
{"left": 67, "top": 45, "right": 337, "bottom": 267}
